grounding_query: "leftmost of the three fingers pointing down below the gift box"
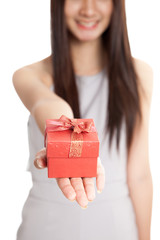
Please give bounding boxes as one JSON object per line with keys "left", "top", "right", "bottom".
{"left": 56, "top": 178, "right": 76, "bottom": 201}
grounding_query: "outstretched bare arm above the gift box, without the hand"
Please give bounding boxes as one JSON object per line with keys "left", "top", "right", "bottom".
{"left": 13, "top": 66, "right": 73, "bottom": 134}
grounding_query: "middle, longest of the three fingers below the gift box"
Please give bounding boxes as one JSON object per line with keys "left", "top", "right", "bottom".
{"left": 71, "top": 178, "right": 88, "bottom": 208}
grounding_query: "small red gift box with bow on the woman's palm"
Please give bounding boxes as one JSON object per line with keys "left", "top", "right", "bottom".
{"left": 44, "top": 116, "right": 99, "bottom": 178}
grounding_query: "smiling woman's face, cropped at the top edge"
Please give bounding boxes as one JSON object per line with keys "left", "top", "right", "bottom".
{"left": 64, "top": 0, "right": 113, "bottom": 41}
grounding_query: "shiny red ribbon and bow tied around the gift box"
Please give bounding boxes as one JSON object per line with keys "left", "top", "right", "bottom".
{"left": 44, "top": 115, "right": 96, "bottom": 157}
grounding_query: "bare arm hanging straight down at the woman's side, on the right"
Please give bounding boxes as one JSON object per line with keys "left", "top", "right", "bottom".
{"left": 127, "top": 58, "right": 153, "bottom": 240}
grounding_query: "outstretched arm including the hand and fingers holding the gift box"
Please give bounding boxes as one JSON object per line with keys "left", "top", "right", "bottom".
{"left": 13, "top": 66, "right": 105, "bottom": 207}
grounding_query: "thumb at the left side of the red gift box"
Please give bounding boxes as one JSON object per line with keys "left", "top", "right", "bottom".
{"left": 34, "top": 148, "right": 47, "bottom": 169}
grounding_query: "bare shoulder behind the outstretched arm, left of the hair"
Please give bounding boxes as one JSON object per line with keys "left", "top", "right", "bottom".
{"left": 12, "top": 57, "right": 53, "bottom": 88}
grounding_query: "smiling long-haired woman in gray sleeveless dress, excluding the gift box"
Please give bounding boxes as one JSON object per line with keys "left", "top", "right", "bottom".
{"left": 13, "top": 0, "right": 152, "bottom": 240}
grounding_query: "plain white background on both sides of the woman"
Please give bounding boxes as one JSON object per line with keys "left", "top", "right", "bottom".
{"left": 0, "top": 0, "right": 160, "bottom": 240}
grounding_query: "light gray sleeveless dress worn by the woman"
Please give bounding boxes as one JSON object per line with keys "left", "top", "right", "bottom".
{"left": 17, "top": 70, "right": 138, "bottom": 240}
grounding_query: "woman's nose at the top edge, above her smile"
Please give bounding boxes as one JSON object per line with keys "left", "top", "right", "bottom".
{"left": 80, "top": 0, "right": 96, "bottom": 17}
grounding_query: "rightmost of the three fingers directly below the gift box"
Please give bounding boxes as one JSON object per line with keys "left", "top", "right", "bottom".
{"left": 83, "top": 177, "right": 95, "bottom": 202}
